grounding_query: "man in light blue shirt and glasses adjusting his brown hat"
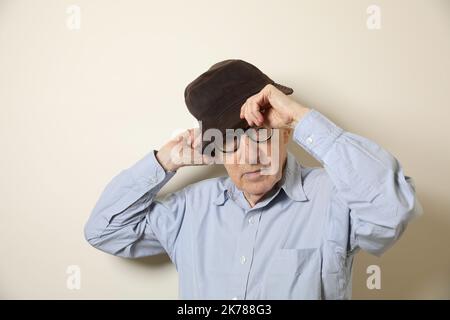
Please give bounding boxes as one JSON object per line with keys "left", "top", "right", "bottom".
{"left": 85, "top": 60, "right": 418, "bottom": 299}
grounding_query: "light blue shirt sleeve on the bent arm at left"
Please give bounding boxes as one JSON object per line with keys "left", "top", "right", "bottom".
{"left": 84, "top": 151, "right": 185, "bottom": 258}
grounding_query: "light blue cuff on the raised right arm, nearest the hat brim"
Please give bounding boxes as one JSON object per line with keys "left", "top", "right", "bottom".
{"left": 294, "top": 110, "right": 344, "bottom": 163}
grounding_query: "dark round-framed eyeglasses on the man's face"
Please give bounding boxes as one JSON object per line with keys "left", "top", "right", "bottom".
{"left": 215, "top": 127, "right": 273, "bottom": 153}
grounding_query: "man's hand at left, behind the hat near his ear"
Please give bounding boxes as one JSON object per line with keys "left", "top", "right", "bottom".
{"left": 156, "top": 128, "right": 213, "bottom": 171}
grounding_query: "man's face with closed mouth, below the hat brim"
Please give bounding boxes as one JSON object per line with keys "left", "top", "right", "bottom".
{"left": 224, "top": 129, "right": 291, "bottom": 195}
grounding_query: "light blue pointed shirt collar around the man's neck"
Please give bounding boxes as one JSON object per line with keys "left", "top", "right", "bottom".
{"left": 214, "top": 152, "right": 308, "bottom": 205}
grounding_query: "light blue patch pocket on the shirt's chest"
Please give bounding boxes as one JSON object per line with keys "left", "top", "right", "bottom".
{"left": 263, "top": 248, "right": 321, "bottom": 299}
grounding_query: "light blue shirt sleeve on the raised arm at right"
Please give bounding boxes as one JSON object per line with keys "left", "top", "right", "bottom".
{"left": 294, "top": 110, "right": 421, "bottom": 256}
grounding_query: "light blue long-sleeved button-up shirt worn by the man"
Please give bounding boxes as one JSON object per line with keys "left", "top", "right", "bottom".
{"left": 85, "top": 110, "right": 420, "bottom": 299}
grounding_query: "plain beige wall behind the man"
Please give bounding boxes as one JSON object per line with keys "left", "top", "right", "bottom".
{"left": 0, "top": 0, "right": 450, "bottom": 299}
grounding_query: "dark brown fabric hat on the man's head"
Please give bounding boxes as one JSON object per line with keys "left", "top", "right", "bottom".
{"left": 184, "top": 59, "right": 294, "bottom": 133}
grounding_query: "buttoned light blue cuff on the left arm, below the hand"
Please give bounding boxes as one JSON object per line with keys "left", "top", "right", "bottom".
{"left": 128, "top": 150, "right": 176, "bottom": 188}
